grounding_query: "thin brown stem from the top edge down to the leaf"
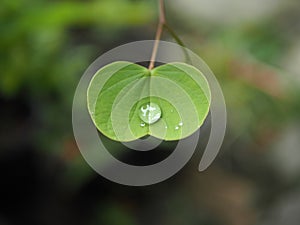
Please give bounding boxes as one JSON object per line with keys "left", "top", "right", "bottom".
{"left": 148, "top": 0, "right": 166, "bottom": 70}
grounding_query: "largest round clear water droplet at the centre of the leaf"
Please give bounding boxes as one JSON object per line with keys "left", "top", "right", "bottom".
{"left": 139, "top": 102, "right": 161, "bottom": 124}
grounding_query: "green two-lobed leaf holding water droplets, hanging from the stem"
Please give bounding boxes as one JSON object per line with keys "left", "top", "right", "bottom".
{"left": 87, "top": 62, "right": 210, "bottom": 142}
